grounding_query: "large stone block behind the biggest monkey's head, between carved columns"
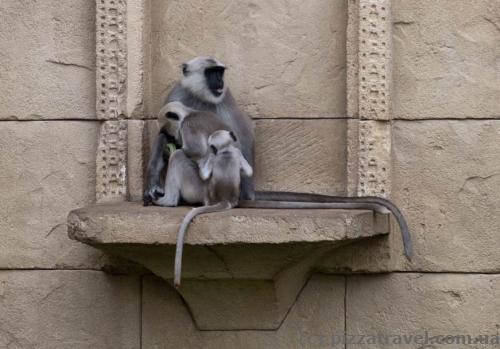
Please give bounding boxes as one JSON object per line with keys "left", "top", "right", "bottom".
{"left": 151, "top": 0, "right": 347, "bottom": 118}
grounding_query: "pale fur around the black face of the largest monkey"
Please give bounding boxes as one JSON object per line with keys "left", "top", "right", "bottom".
{"left": 181, "top": 56, "right": 226, "bottom": 104}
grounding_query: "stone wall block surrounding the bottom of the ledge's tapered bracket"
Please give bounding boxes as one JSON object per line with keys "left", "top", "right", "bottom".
{"left": 142, "top": 275, "right": 344, "bottom": 349}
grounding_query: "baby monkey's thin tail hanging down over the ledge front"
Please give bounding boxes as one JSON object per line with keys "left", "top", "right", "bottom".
{"left": 174, "top": 201, "right": 232, "bottom": 288}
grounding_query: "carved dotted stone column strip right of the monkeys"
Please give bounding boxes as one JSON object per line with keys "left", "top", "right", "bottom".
{"left": 347, "top": 0, "right": 392, "bottom": 197}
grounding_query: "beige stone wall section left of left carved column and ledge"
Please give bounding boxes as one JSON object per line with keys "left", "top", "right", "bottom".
{"left": 0, "top": 0, "right": 141, "bottom": 349}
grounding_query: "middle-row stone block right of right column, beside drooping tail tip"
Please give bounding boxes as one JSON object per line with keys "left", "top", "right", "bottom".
{"left": 391, "top": 120, "right": 500, "bottom": 272}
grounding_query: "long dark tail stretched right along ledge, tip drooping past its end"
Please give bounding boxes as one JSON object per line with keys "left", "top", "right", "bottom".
{"left": 252, "top": 191, "right": 413, "bottom": 260}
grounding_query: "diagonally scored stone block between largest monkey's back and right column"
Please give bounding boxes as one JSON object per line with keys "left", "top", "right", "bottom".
{"left": 255, "top": 119, "right": 347, "bottom": 195}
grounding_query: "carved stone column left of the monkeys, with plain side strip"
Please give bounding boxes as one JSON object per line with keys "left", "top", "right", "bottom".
{"left": 96, "top": 0, "right": 149, "bottom": 202}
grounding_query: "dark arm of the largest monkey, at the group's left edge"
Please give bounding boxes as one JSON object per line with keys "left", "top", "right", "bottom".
{"left": 143, "top": 132, "right": 169, "bottom": 206}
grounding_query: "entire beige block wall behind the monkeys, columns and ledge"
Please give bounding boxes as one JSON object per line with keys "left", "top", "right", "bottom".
{"left": 0, "top": 0, "right": 500, "bottom": 349}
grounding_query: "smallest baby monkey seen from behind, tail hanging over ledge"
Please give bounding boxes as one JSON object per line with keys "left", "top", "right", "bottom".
{"left": 174, "top": 130, "right": 253, "bottom": 288}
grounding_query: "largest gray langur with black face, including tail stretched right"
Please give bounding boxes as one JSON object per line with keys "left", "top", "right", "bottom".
{"left": 144, "top": 57, "right": 412, "bottom": 259}
